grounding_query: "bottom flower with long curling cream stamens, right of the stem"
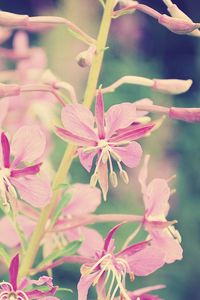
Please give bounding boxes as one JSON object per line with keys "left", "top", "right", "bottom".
{"left": 78, "top": 224, "right": 164, "bottom": 300}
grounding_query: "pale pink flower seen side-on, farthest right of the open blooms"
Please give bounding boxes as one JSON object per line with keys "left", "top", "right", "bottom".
{"left": 139, "top": 156, "right": 183, "bottom": 263}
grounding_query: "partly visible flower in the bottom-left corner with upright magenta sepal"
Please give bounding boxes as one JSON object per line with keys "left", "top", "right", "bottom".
{"left": 0, "top": 254, "right": 59, "bottom": 300}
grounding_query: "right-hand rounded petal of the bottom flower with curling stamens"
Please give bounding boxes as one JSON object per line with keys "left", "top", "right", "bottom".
{"left": 128, "top": 246, "right": 165, "bottom": 276}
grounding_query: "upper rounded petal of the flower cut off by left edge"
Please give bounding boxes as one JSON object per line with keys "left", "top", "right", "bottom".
{"left": 11, "top": 126, "right": 46, "bottom": 165}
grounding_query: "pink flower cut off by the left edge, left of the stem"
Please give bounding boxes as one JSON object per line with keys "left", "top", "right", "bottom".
{"left": 0, "top": 126, "right": 51, "bottom": 208}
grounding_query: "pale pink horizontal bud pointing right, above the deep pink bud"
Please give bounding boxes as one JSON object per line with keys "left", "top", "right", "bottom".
{"left": 152, "top": 79, "right": 192, "bottom": 95}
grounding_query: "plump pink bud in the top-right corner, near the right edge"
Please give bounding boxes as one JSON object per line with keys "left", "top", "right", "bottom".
{"left": 158, "top": 15, "right": 199, "bottom": 34}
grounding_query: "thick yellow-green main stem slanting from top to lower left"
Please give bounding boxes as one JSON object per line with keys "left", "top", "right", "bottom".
{"left": 19, "top": 0, "right": 115, "bottom": 278}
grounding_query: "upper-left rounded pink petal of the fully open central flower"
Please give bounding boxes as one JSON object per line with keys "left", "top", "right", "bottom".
{"left": 61, "top": 104, "right": 97, "bottom": 141}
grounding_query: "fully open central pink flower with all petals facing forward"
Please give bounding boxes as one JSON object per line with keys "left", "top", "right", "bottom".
{"left": 57, "top": 92, "right": 153, "bottom": 199}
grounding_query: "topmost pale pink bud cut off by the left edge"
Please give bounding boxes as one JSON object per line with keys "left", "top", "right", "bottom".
{"left": 0, "top": 11, "right": 29, "bottom": 27}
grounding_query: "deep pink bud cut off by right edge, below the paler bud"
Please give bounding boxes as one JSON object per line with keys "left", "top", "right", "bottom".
{"left": 169, "top": 107, "right": 200, "bottom": 123}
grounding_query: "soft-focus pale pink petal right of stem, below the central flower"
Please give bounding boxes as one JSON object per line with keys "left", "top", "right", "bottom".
{"left": 64, "top": 183, "right": 101, "bottom": 216}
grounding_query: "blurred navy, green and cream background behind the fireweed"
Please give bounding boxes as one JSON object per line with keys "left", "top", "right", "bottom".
{"left": 0, "top": 0, "right": 200, "bottom": 300}
